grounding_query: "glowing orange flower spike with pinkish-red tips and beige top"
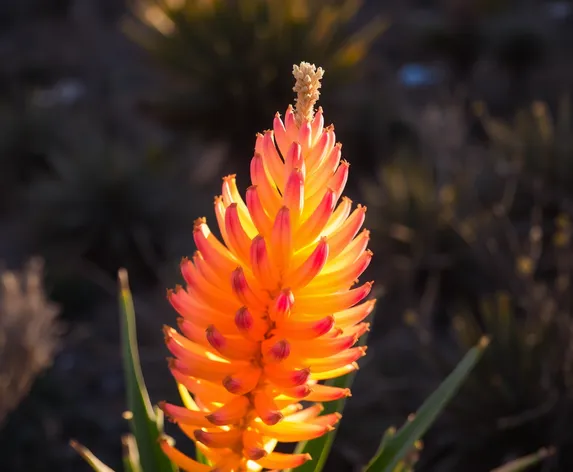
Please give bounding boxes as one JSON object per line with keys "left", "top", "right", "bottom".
{"left": 161, "top": 62, "right": 374, "bottom": 472}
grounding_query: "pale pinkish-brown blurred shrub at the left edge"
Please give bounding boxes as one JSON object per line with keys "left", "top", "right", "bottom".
{"left": 0, "top": 260, "right": 60, "bottom": 425}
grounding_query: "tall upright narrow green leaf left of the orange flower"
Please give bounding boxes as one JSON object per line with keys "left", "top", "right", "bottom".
{"left": 119, "top": 270, "right": 177, "bottom": 472}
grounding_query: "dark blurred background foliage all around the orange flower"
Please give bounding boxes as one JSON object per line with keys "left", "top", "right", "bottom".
{"left": 0, "top": 0, "right": 573, "bottom": 472}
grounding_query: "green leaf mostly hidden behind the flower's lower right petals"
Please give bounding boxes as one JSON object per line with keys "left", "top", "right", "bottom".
{"left": 287, "top": 313, "right": 374, "bottom": 472}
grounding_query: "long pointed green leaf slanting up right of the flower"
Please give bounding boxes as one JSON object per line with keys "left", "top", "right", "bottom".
{"left": 364, "top": 337, "right": 489, "bottom": 472}
